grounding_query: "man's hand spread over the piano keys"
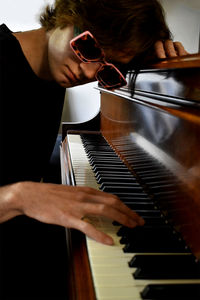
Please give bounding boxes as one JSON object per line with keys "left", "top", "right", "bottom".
{"left": 4, "top": 182, "right": 144, "bottom": 245}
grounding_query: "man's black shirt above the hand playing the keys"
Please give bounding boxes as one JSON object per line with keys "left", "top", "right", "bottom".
{"left": 0, "top": 24, "right": 65, "bottom": 185}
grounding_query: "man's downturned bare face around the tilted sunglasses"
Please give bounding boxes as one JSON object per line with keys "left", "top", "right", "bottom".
{"left": 48, "top": 26, "right": 133, "bottom": 88}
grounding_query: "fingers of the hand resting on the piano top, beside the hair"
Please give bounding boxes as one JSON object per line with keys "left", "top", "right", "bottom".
{"left": 154, "top": 40, "right": 189, "bottom": 58}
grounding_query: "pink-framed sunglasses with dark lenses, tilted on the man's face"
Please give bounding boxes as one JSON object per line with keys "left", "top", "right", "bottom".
{"left": 70, "top": 31, "right": 127, "bottom": 89}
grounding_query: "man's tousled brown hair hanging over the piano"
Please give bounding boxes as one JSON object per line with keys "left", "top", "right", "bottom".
{"left": 40, "top": 0, "right": 170, "bottom": 60}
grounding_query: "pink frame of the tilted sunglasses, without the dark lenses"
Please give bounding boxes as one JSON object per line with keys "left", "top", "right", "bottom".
{"left": 70, "top": 31, "right": 127, "bottom": 89}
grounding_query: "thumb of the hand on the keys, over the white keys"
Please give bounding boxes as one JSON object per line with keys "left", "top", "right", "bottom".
{"left": 70, "top": 218, "right": 114, "bottom": 245}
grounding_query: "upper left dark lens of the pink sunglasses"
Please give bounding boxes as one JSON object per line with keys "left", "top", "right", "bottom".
{"left": 72, "top": 34, "right": 102, "bottom": 60}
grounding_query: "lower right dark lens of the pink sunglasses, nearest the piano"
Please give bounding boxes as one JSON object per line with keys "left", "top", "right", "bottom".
{"left": 96, "top": 65, "right": 127, "bottom": 88}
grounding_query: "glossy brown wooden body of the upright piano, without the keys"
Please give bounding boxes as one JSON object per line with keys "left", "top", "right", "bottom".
{"left": 60, "top": 54, "right": 200, "bottom": 300}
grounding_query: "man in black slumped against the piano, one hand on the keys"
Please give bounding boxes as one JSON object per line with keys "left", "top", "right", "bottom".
{"left": 0, "top": 0, "right": 190, "bottom": 299}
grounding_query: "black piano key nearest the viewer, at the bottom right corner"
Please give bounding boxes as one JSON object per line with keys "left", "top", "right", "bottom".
{"left": 141, "top": 284, "right": 200, "bottom": 300}
